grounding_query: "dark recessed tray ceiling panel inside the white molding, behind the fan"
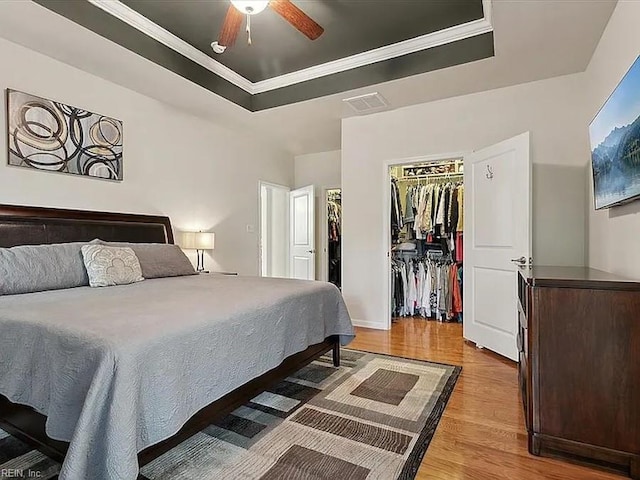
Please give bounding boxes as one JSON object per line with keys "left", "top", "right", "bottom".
{"left": 122, "top": 0, "right": 483, "bottom": 83}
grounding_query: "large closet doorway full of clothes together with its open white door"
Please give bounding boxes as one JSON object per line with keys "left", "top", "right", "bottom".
{"left": 384, "top": 132, "right": 533, "bottom": 361}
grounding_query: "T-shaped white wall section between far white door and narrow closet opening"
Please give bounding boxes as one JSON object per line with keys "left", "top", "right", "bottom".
{"left": 294, "top": 150, "right": 342, "bottom": 279}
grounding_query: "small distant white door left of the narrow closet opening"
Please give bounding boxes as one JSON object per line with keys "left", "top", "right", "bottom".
{"left": 289, "top": 185, "right": 316, "bottom": 280}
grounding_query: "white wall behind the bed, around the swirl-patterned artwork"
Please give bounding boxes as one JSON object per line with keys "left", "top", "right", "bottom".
{"left": 0, "top": 40, "right": 293, "bottom": 274}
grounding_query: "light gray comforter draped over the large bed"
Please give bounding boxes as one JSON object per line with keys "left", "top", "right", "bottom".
{"left": 0, "top": 275, "right": 353, "bottom": 480}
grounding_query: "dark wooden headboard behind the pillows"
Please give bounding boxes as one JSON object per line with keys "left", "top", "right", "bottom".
{"left": 0, "top": 205, "right": 173, "bottom": 247}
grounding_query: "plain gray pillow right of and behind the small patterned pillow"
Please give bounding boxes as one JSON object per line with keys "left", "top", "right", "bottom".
{"left": 91, "top": 240, "right": 197, "bottom": 278}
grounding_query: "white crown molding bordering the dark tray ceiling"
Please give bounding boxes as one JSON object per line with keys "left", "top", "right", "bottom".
{"left": 87, "top": 0, "right": 493, "bottom": 95}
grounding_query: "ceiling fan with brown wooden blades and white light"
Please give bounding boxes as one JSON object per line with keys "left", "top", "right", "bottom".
{"left": 211, "top": 0, "right": 324, "bottom": 53}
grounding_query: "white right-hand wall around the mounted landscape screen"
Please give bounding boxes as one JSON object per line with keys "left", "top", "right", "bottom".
{"left": 585, "top": 1, "right": 640, "bottom": 279}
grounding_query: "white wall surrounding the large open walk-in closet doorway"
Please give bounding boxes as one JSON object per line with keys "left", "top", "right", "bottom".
{"left": 342, "top": 74, "right": 588, "bottom": 328}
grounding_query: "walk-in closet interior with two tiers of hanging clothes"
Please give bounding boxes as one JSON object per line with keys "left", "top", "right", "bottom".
{"left": 389, "top": 158, "right": 464, "bottom": 322}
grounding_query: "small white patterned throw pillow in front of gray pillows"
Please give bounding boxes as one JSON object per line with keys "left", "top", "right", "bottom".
{"left": 81, "top": 245, "right": 144, "bottom": 287}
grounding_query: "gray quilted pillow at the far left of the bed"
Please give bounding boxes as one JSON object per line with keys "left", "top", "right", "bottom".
{"left": 0, "top": 242, "right": 89, "bottom": 295}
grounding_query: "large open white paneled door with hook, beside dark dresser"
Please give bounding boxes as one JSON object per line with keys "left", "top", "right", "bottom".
{"left": 463, "top": 132, "right": 531, "bottom": 361}
